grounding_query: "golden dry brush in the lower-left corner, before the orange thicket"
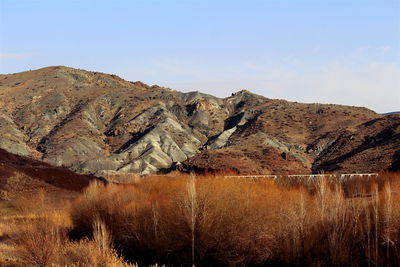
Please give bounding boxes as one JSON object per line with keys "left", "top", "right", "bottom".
{"left": 7, "top": 215, "right": 133, "bottom": 267}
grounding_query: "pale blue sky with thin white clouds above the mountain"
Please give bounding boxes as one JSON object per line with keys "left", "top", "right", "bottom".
{"left": 0, "top": 0, "right": 400, "bottom": 113}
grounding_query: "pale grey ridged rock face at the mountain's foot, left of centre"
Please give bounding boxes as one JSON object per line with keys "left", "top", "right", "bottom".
{"left": 72, "top": 104, "right": 202, "bottom": 175}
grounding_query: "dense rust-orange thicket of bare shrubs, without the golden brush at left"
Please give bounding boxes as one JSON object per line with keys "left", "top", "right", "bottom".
{"left": 71, "top": 175, "right": 400, "bottom": 266}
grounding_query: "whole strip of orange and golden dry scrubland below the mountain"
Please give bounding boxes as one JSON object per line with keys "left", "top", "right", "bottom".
{"left": 0, "top": 174, "right": 400, "bottom": 266}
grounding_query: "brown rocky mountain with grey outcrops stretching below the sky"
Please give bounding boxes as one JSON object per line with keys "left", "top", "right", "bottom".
{"left": 0, "top": 66, "right": 400, "bottom": 175}
